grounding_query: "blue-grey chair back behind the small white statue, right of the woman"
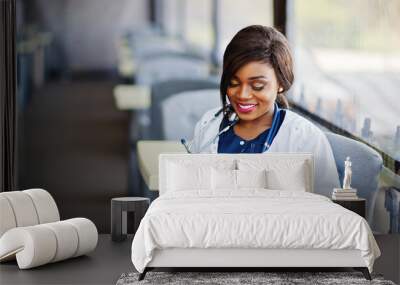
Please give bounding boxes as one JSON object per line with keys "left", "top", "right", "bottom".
{"left": 326, "top": 133, "right": 382, "bottom": 224}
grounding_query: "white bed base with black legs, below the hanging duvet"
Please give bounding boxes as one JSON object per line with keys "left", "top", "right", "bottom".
{"left": 139, "top": 248, "right": 371, "bottom": 281}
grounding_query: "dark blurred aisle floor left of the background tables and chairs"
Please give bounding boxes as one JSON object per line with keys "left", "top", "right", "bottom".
{"left": 18, "top": 79, "right": 129, "bottom": 233}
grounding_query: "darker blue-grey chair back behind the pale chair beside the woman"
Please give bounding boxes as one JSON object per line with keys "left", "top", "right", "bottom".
{"left": 150, "top": 78, "right": 219, "bottom": 140}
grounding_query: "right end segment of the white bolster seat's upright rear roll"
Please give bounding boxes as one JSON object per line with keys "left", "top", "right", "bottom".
{"left": 22, "top": 188, "right": 60, "bottom": 224}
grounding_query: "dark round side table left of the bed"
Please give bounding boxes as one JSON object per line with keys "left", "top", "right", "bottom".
{"left": 111, "top": 197, "right": 150, "bottom": 241}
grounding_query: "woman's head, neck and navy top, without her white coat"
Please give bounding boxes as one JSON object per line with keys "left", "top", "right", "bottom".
{"left": 218, "top": 25, "right": 294, "bottom": 153}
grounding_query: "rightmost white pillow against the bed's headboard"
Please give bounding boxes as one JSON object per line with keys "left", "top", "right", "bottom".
{"left": 267, "top": 162, "right": 308, "bottom": 192}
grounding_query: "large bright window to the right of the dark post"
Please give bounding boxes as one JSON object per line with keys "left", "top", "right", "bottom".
{"left": 287, "top": 0, "right": 400, "bottom": 160}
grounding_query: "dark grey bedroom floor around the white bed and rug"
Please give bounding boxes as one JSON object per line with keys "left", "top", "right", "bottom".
{"left": 0, "top": 235, "right": 400, "bottom": 285}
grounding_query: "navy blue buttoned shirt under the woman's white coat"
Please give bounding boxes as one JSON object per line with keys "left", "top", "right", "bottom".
{"left": 218, "top": 110, "right": 285, "bottom": 153}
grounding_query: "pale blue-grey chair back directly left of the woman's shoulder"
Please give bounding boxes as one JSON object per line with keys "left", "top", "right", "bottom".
{"left": 161, "top": 89, "right": 221, "bottom": 140}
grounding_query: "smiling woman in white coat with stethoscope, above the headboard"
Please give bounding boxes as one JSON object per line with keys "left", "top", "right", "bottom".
{"left": 191, "top": 25, "right": 339, "bottom": 196}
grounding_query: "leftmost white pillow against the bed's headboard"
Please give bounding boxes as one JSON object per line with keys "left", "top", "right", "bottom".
{"left": 167, "top": 162, "right": 211, "bottom": 191}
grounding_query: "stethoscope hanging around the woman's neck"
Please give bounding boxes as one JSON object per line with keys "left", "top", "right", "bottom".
{"left": 181, "top": 103, "right": 281, "bottom": 153}
